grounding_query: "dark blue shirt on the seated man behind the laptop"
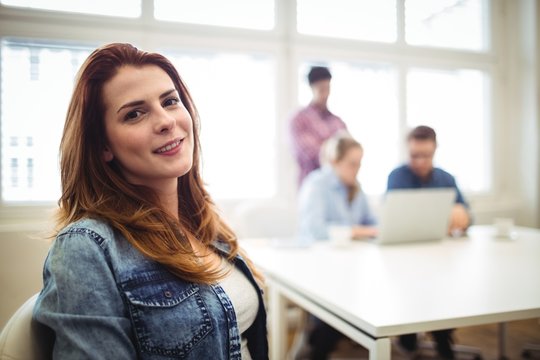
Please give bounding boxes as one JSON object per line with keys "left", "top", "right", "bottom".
{"left": 387, "top": 165, "right": 469, "bottom": 207}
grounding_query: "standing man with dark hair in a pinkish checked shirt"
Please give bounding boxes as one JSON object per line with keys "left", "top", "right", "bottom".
{"left": 290, "top": 66, "right": 347, "bottom": 184}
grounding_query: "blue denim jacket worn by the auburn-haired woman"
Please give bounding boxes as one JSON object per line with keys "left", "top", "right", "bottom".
{"left": 34, "top": 219, "right": 268, "bottom": 360}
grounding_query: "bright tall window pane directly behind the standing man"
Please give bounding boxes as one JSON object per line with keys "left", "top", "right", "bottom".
{"left": 299, "top": 61, "right": 399, "bottom": 194}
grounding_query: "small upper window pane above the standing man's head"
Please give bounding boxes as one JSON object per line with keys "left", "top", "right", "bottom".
{"left": 297, "top": 0, "right": 397, "bottom": 42}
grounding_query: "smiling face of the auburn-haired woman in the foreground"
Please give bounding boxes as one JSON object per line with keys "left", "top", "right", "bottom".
{"left": 103, "top": 65, "right": 194, "bottom": 191}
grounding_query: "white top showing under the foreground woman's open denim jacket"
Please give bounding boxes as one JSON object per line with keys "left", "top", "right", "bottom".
{"left": 219, "top": 260, "right": 259, "bottom": 360}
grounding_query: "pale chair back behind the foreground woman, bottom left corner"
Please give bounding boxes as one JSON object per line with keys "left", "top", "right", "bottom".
{"left": 0, "top": 294, "right": 53, "bottom": 360}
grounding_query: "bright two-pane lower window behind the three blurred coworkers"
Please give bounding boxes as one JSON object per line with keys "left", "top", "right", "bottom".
{"left": 299, "top": 61, "right": 491, "bottom": 195}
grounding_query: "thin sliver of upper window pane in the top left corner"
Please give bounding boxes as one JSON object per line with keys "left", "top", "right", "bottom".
{"left": 0, "top": 0, "right": 141, "bottom": 18}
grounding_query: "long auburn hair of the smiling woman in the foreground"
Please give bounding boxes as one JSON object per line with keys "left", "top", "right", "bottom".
{"left": 57, "top": 43, "right": 258, "bottom": 283}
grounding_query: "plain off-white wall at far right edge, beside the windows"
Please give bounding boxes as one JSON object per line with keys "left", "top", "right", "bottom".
{"left": 501, "top": 0, "right": 540, "bottom": 227}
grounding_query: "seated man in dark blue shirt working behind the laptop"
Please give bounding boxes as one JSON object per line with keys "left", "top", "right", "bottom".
{"left": 387, "top": 126, "right": 471, "bottom": 359}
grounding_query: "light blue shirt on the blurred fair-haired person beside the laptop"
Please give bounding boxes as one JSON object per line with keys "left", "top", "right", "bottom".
{"left": 299, "top": 165, "right": 376, "bottom": 240}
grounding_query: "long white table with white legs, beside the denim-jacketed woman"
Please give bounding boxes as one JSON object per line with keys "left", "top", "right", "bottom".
{"left": 241, "top": 226, "right": 540, "bottom": 360}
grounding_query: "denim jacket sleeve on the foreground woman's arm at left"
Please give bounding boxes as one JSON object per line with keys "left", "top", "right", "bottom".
{"left": 34, "top": 232, "right": 137, "bottom": 359}
